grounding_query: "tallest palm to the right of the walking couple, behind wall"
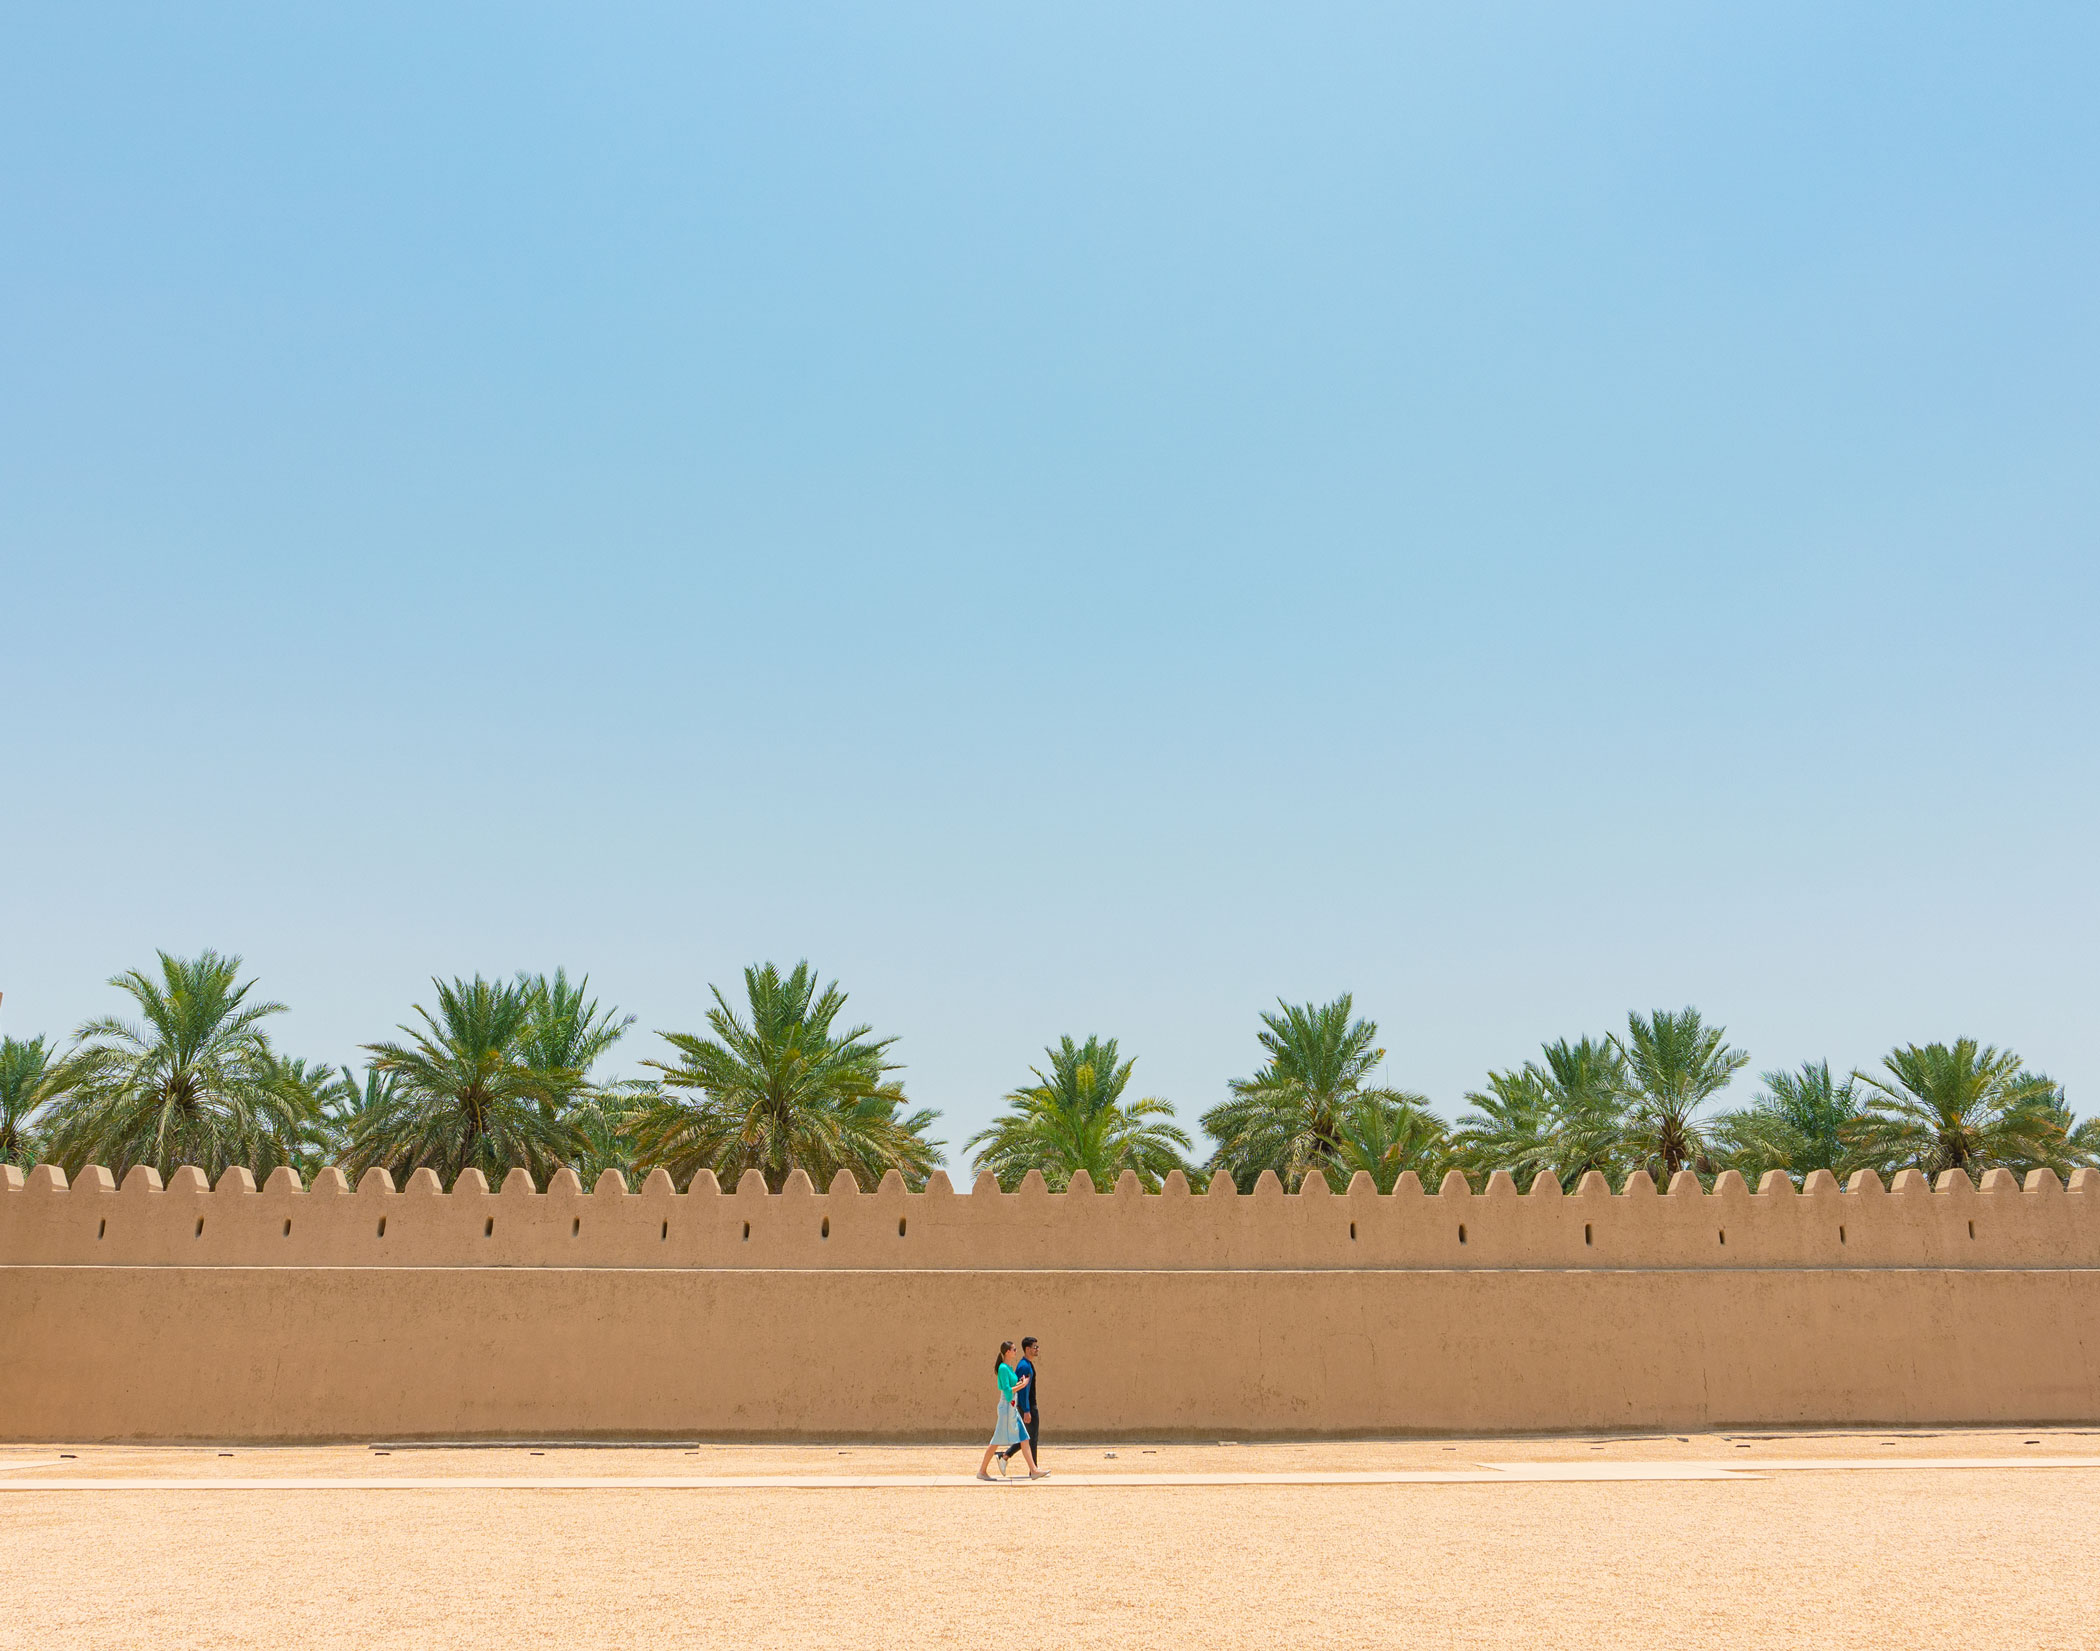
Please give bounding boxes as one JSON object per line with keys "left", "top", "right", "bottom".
{"left": 1203, "top": 991, "right": 1428, "bottom": 1187}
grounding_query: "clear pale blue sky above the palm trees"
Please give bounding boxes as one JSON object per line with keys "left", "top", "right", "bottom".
{"left": 0, "top": 0, "right": 2100, "bottom": 1145}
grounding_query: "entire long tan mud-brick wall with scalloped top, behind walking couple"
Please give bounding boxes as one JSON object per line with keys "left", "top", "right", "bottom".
{"left": 0, "top": 1168, "right": 2100, "bottom": 1441}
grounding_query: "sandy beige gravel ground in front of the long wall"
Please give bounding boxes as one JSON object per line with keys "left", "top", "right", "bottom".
{"left": 0, "top": 1430, "right": 2100, "bottom": 1647}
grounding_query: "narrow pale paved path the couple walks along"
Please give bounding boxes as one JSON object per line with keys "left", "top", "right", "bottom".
{"left": 12, "top": 1456, "right": 2100, "bottom": 1493}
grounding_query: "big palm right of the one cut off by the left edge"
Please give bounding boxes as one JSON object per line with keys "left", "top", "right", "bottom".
{"left": 44, "top": 952, "right": 315, "bottom": 1180}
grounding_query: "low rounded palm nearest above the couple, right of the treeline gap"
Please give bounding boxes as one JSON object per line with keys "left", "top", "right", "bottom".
{"left": 962, "top": 1038, "right": 1189, "bottom": 1193}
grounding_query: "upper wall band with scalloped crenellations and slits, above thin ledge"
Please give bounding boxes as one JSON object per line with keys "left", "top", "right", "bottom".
{"left": 0, "top": 1164, "right": 2100, "bottom": 1271}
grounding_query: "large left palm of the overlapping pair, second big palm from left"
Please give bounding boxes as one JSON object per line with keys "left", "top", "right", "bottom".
{"left": 347, "top": 975, "right": 584, "bottom": 1185}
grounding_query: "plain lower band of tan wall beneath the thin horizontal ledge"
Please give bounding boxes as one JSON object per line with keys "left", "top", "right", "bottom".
{"left": 0, "top": 1267, "right": 2100, "bottom": 1441}
